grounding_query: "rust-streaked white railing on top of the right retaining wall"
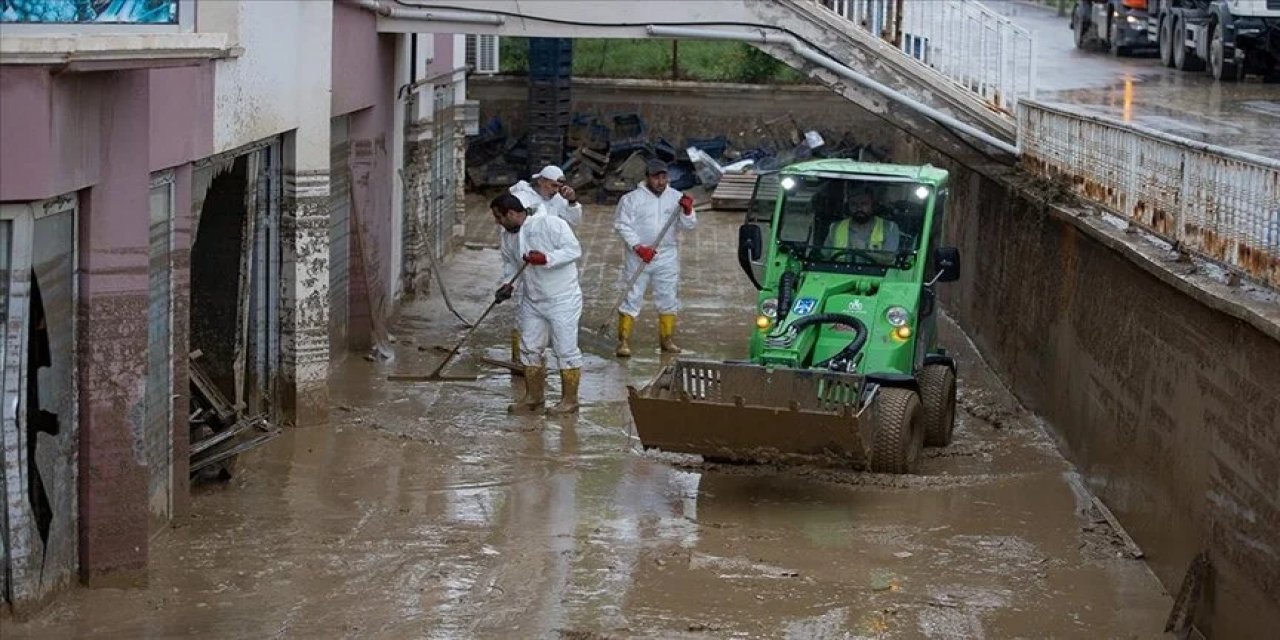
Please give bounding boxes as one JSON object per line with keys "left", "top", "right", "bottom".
{"left": 1018, "top": 101, "right": 1280, "bottom": 288}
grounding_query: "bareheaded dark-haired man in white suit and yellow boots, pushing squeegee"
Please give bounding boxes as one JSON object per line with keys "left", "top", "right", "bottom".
{"left": 489, "top": 193, "right": 582, "bottom": 415}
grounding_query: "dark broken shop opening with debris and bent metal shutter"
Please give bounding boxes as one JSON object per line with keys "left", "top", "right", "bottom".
{"left": 186, "top": 138, "right": 284, "bottom": 479}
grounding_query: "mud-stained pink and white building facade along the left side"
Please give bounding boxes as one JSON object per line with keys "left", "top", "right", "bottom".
{"left": 0, "top": 0, "right": 471, "bottom": 614}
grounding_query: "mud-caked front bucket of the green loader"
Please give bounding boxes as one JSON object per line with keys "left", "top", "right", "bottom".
{"left": 627, "top": 360, "right": 870, "bottom": 468}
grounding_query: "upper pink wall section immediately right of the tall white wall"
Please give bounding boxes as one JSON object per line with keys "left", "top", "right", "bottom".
{"left": 330, "top": 3, "right": 378, "bottom": 116}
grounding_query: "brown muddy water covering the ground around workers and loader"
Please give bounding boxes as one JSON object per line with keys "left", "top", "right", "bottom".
{"left": 3, "top": 195, "right": 1171, "bottom": 640}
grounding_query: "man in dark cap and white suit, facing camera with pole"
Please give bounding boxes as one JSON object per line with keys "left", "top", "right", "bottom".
{"left": 613, "top": 160, "right": 698, "bottom": 357}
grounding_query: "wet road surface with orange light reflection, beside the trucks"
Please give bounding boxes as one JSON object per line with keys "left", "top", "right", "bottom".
{"left": 989, "top": 0, "right": 1280, "bottom": 159}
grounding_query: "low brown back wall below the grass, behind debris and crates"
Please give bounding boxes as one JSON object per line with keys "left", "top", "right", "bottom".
{"left": 467, "top": 76, "right": 893, "bottom": 153}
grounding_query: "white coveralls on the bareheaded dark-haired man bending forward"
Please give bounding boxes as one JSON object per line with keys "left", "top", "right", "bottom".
{"left": 502, "top": 215, "right": 582, "bottom": 369}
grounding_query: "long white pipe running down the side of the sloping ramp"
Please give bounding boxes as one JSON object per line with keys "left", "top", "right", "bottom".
{"left": 645, "top": 24, "right": 1019, "bottom": 156}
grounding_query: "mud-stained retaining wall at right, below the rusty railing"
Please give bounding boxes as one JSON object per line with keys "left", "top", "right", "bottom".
{"left": 900, "top": 138, "right": 1280, "bottom": 637}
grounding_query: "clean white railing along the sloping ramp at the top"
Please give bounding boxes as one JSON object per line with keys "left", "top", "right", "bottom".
{"left": 814, "top": 0, "right": 1036, "bottom": 115}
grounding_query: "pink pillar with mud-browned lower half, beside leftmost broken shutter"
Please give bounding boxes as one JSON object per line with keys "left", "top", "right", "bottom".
{"left": 77, "top": 70, "right": 151, "bottom": 584}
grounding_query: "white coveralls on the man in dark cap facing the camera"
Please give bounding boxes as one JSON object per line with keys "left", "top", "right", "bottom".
{"left": 613, "top": 183, "right": 698, "bottom": 317}
